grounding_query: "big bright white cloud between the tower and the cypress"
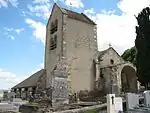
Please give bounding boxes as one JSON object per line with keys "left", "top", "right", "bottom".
{"left": 86, "top": 0, "right": 150, "bottom": 54}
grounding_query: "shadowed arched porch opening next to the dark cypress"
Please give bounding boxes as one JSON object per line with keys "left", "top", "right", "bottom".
{"left": 121, "top": 65, "right": 137, "bottom": 93}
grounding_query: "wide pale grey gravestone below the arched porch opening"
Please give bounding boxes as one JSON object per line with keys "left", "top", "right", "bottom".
{"left": 126, "top": 93, "right": 139, "bottom": 110}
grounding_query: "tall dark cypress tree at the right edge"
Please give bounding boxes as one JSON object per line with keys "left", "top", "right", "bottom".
{"left": 135, "top": 7, "right": 150, "bottom": 89}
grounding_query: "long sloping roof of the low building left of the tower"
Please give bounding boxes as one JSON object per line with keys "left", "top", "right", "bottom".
{"left": 12, "top": 69, "right": 45, "bottom": 89}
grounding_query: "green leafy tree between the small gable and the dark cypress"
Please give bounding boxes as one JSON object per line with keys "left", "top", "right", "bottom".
{"left": 121, "top": 47, "right": 137, "bottom": 66}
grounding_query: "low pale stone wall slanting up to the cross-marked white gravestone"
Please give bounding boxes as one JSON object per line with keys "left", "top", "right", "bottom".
{"left": 53, "top": 104, "right": 107, "bottom": 113}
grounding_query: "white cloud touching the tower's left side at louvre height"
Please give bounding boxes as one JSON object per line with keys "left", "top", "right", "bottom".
{"left": 25, "top": 18, "right": 46, "bottom": 44}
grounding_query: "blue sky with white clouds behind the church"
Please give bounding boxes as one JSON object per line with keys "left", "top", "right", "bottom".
{"left": 0, "top": 0, "right": 150, "bottom": 89}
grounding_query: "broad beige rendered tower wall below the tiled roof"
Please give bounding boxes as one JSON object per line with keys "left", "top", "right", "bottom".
{"left": 64, "top": 18, "right": 97, "bottom": 92}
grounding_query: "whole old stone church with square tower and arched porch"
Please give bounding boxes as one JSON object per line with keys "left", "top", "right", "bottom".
{"left": 12, "top": 4, "right": 138, "bottom": 98}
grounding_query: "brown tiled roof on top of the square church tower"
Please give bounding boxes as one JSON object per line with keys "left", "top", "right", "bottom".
{"left": 61, "top": 8, "right": 96, "bottom": 25}
